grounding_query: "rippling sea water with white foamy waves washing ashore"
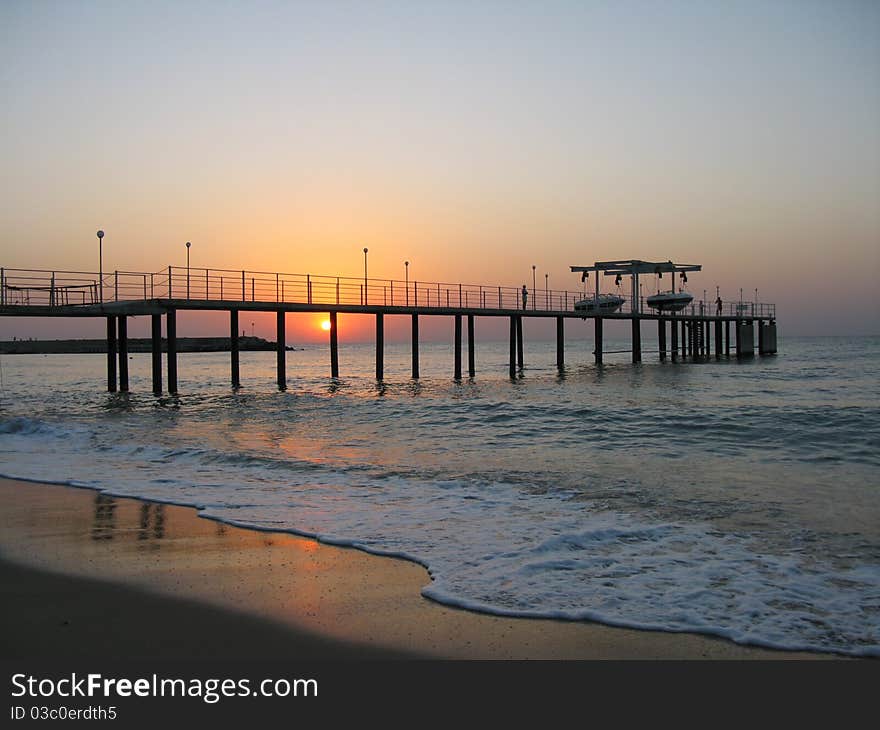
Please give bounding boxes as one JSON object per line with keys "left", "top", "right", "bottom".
{"left": 0, "top": 338, "right": 880, "bottom": 656}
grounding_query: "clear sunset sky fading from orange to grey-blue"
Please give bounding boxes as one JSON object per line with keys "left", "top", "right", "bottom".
{"left": 0, "top": 0, "right": 880, "bottom": 339}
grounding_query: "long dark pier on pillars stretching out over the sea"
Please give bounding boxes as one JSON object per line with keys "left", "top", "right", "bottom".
{"left": 0, "top": 260, "right": 777, "bottom": 395}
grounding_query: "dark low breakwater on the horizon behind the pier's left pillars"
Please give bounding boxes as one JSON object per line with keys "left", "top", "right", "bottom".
{"left": 0, "top": 337, "right": 297, "bottom": 355}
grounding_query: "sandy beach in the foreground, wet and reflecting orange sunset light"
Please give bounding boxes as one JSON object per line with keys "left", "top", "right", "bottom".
{"left": 0, "top": 479, "right": 823, "bottom": 659}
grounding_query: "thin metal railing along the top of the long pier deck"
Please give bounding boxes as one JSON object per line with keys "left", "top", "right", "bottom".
{"left": 0, "top": 266, "right": 776, "bottom": 319}
